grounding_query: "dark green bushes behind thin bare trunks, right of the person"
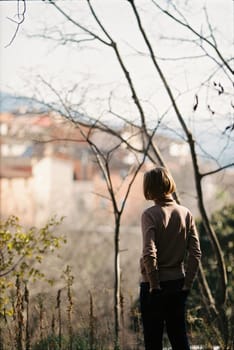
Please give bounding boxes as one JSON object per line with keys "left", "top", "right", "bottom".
{"left": 188, "top": 204, "right": 234, "bottom": 348}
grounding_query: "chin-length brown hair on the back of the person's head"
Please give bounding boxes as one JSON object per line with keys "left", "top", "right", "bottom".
{"left": 143, "top": 167, "right": 176, "bottom": 200}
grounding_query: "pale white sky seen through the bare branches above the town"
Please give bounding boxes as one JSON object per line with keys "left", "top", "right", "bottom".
{"left": 0, "top": 0, "right": 234, "bottom": 163}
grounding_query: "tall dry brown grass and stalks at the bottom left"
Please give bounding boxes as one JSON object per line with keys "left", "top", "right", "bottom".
{"left": 0, "top": 268, "right": 142, "bottom": 350}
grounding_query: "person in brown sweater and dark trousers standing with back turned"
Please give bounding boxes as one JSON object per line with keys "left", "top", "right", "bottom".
{"left": 140, "top": 167, "right": 201, "bottom": 350}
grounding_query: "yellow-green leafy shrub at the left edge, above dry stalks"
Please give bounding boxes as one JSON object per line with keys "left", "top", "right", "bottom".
{"left": 0, "top": 216, "right": 65, "bottom": 313}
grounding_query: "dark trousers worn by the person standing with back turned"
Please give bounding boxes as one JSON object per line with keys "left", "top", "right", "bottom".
{"left": 140, "top": 279, "right": 190, "bottom": 350}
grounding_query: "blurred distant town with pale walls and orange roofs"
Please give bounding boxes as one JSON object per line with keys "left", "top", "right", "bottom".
{"left": 0, "top": 97, "right": 234, "bottom": 227}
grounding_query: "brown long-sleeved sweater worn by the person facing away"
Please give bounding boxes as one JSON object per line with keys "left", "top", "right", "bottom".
{"left": 140, "top": 196, "right": 201, "bottom": 289}
